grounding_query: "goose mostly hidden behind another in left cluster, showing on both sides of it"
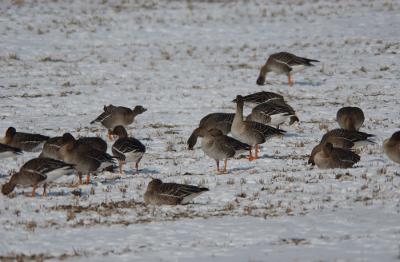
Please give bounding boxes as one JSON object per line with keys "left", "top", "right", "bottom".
{"left": 39, "top": 136, "right": 107, "bottom": 160}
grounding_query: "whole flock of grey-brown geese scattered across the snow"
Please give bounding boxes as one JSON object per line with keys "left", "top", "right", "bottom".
{"left": 0, "top": 52, "right": 400, "bottom": 205}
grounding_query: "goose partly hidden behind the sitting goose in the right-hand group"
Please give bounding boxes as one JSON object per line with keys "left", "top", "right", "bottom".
{"left": 308, "top": 128, "right": 375, "bottom": 165}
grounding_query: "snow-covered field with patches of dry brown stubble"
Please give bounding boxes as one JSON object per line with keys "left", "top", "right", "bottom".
{"left": 0, "top": 0, "right": 400, "bottom": 261}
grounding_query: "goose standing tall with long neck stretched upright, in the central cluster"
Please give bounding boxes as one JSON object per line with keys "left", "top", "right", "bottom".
{"left": 231, "top": 95, "right": 286, "bottom": 161}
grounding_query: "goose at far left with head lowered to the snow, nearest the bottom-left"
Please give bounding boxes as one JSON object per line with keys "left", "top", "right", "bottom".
{"left": 1, "top": 158, "right": 74, "bottom": 197}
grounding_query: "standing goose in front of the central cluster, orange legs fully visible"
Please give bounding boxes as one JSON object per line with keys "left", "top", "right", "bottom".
{"left": 201, "top": 128, "right": 250, "bottom": 173}
